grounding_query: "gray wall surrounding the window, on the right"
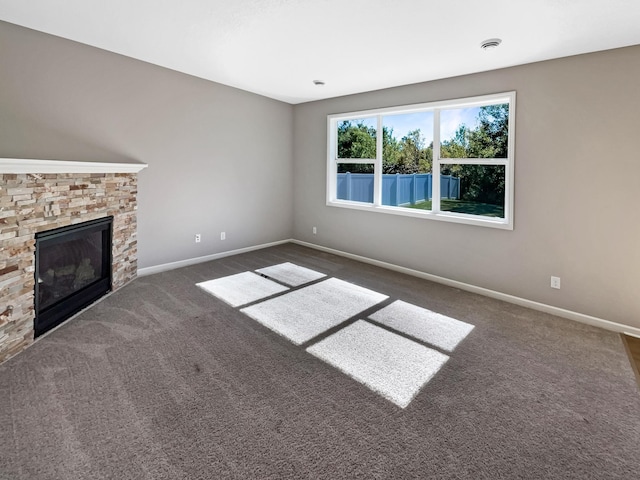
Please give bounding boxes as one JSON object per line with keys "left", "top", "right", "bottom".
{"left": 293, "top": 46, "right": 640, "bottom": 327}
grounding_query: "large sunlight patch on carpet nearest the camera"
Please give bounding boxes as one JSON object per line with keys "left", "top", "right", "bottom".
{"left": 307, "top": 320, "right": 449, "bottom": 408}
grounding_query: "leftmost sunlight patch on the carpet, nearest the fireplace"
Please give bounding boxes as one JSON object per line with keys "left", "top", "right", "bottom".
{"left": 196, "top": 272, "right": 289, "bottom": 307}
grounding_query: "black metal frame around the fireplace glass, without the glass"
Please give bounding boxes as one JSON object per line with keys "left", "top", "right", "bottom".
{"left": 34, "top": 216, "right": 113, "bottom": 337}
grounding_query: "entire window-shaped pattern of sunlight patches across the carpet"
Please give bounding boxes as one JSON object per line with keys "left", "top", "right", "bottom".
{"left": 197, "top": 262, "right": 474, "bottom": 408}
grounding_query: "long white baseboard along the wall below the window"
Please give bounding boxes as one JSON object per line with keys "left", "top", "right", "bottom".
{"left": 291, "top": 240, "right": 640, "bottom": 336}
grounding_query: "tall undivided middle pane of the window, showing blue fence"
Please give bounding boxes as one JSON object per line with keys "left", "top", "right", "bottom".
{"left": 382, "top": 112, "right": 433, "bottom": 210}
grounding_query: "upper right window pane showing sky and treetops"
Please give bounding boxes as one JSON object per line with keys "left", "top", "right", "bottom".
{"left": 440, "top": 103, "right": 509, "bottom": 158}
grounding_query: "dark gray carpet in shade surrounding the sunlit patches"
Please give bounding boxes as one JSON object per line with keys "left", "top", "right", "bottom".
{"left": 0, "top": 245, "right": 640, "bottom": 480}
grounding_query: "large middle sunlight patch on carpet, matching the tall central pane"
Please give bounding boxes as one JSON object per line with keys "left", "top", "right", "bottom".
{"left": 241, "top": 278, "right": 388, "bottom": 345}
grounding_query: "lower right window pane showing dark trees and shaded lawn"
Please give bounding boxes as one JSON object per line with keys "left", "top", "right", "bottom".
{"left": 440, "top": 165, "right": 505, "bottom": 218}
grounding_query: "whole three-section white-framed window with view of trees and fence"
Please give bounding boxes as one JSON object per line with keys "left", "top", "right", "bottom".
{"left": 327, "top": 92, "right": 515, "bottom": 229}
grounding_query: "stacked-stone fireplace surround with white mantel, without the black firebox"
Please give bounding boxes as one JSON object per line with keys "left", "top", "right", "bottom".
{"left": 0, "top": 159, "right": 146, "bottom": 362}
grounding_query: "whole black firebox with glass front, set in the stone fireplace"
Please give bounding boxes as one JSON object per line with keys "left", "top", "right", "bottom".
{"left": 34, "top": 217, "right": 113, "bottom": 337}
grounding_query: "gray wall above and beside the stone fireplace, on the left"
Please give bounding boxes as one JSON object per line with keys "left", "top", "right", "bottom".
{"left": 0, "top": 22, "right": 293, "bottom": 267}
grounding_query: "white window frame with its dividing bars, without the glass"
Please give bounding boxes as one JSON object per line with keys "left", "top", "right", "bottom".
{"left": 327, "top": 91, "right": 516, "bottom": 230}
